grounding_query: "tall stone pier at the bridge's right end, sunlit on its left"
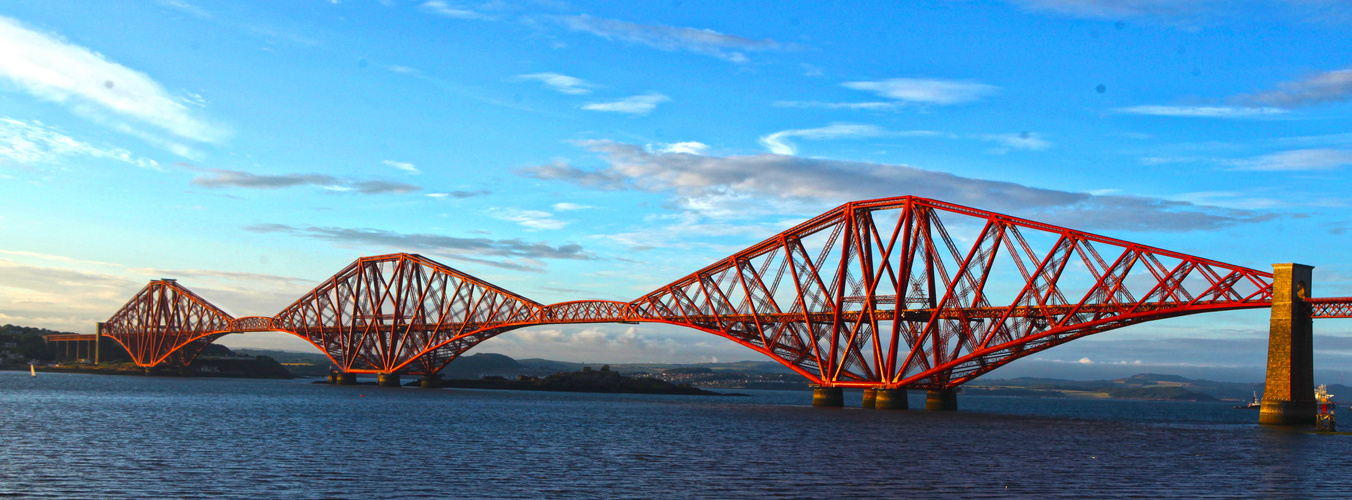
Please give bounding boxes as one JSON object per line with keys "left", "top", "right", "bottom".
{"left": 1259, "top": 264, "right": 1314, "bottom": 426}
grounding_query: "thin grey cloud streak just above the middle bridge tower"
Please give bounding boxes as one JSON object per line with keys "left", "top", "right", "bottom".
{"left": 245, "top": 224, "right": 596, "bottom": 272}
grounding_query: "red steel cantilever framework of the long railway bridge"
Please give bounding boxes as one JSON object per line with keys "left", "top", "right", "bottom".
{"left": 104, "top": 196, "right": 1352, "bottom": 389}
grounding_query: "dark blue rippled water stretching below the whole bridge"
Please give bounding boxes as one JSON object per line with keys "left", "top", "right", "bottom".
{"left": 0, "top": 372, "right": 1352, "bottom": 499}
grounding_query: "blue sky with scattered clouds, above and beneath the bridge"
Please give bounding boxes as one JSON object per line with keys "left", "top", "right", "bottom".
{"left": 0, "top": 0, "right": 1352, "bottom": 376}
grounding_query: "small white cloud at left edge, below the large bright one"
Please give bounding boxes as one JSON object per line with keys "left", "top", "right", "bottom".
{"left": 0, "top": 118, "right": 160, "bottom": 169}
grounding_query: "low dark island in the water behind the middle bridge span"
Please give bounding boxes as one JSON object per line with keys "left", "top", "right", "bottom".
{"left": 441, "top": 365, "right": 745, "bottom": 396}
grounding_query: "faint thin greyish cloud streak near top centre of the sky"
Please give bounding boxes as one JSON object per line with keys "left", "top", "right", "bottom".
{"left": 558, "top": 14, "right": 791, "bottom": 62}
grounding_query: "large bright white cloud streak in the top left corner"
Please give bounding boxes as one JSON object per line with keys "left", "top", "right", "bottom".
{"left": 0, "top": 16, "right": 227, "bottom": 142}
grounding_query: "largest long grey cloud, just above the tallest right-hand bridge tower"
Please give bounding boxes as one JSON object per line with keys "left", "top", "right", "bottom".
{"left": 521, "top": 136, "right": 1276, "bottom": 231}
